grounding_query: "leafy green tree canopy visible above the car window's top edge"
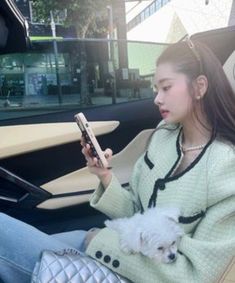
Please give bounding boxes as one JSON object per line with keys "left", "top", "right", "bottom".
{"left": 33, "top": 0, "right": 111, "bottom": 38}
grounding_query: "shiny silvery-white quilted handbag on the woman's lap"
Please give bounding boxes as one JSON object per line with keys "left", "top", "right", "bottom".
{"left": 31, "top": 250, "right": 131, "bottom": 283}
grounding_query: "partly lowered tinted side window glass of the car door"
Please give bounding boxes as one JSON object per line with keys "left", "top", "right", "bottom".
{"left": 0, "top": 40, "right": 166, "bottom": 120}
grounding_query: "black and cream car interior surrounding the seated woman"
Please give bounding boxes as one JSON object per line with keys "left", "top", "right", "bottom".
{"left": 0, "top": 0, "right": 235, "bottom": 283}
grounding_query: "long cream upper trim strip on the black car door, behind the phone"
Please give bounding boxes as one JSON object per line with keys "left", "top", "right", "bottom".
{"left": 0, "top": 121, "right": 119, "bottom": 158}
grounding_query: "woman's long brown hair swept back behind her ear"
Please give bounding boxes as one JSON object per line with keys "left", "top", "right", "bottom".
{"left": 156, "top": 41, "right": 235, "bottom": 145}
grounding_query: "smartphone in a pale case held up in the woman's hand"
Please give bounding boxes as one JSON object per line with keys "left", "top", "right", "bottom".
{"left": 74, "top": 112, "right": 108, "bottom": 168}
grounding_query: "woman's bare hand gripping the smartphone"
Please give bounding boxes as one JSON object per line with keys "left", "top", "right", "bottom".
{"left": 81, "top": 138, "right": 113, "bottom": 188}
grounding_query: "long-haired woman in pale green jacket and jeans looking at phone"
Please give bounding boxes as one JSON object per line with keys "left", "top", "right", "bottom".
{"left": 0, "top": 41, "right": 235, "bottom": 283}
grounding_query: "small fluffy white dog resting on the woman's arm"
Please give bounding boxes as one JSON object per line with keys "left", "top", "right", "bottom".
{"left": 105, "top": 207, "right": 183, "bottom": 263}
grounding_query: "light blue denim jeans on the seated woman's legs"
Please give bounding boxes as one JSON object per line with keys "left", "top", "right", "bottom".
{"left": 0, "top": 213, "right": 87, "bottom": 283}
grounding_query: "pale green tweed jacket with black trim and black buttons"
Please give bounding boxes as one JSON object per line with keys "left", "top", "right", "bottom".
{"left": 86, "top": 125, "right": 235, "bottom": 283}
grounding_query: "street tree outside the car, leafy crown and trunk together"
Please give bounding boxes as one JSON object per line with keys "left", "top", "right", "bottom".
{"left": 33, "top": 0, "right": 111, "bottom": 105}
